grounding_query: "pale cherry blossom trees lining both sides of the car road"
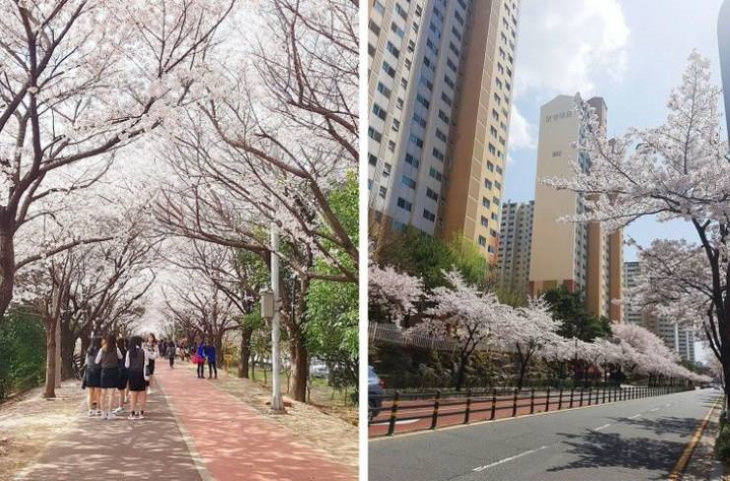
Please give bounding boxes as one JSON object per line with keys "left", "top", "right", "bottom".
{"left": 369, "top": 53, "right": 730, "bottom": 396}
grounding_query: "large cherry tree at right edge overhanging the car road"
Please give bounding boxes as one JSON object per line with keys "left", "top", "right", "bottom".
{"left": 545, "top": 52, "right": 730, "bottom": 396}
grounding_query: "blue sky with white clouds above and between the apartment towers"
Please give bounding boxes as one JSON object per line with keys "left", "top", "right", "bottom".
{"left": 504, "top": 0, "right": 722, "bottom": 260}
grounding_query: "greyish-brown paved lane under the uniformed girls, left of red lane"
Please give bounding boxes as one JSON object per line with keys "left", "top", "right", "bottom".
{"left": 13, "top": 386, "right": 201, "bottom": 481}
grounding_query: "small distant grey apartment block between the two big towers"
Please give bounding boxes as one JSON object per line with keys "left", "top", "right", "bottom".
{"left": 497, "top": 200, "right": 535, "bottom": 293}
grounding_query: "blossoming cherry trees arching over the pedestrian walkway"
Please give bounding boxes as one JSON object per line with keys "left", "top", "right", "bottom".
{"left": 0, "top": 0, "right": 358, "bottom": 400}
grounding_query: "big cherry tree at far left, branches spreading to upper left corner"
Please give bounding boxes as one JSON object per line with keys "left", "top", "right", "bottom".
{"left": 0, "top": 0, "right": 234, "bottom": 314}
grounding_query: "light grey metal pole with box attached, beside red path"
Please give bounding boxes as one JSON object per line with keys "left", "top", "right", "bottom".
{"left": 261, "top": 222, "right": 285, "bottom": 413}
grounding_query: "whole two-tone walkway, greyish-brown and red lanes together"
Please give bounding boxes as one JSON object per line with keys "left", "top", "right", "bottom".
{"left": 12, "top": 369, "right": 357, "bottom": 481}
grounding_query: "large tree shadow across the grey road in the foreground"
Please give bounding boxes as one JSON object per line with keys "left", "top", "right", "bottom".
{"left": 548, "top": 430, "right": 684, "bottom": 481}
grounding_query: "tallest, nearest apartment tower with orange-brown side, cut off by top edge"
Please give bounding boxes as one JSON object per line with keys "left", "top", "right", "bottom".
{"left": 368, "top": 0, "right": 519, "bottom": 261}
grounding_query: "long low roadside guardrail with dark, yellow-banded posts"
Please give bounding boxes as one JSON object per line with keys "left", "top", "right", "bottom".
{"left": 368, "top": 386, "right": 693, "bottom": 436}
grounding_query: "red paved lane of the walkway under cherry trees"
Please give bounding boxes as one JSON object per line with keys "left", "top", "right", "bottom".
{"left": 157, "top": 368, "right": 357, "bottom": 481}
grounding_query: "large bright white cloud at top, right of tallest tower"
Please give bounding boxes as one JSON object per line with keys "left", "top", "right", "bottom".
{"left": 516, "top": 0, "right": 629, "bottom": 97}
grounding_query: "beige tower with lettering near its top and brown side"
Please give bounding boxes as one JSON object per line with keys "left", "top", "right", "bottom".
{"left": 529, "top": 95, "right": 623, "bottom": 322}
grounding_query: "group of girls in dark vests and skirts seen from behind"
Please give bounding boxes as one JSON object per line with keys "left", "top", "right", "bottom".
{"left": 82, "top": 334, "right": 175, "bottom": 420}
